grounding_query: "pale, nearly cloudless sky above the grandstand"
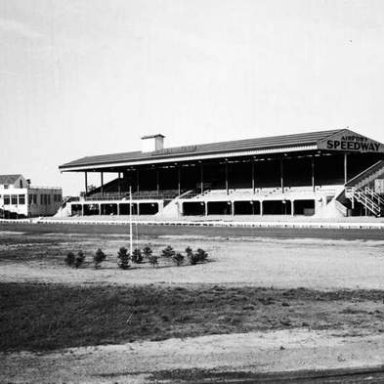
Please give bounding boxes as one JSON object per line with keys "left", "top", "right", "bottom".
{"left": 0, "top": 0, "right": 384, "bottom": 195}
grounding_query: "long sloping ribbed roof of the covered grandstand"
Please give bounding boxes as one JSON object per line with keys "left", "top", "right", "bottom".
{"left": 59, "top": 129, "right": 384, "bottom": 171}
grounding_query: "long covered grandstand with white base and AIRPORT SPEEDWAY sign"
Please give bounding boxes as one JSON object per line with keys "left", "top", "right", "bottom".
{"left": 59, "top": 129, "right": 384, "bottom": 218}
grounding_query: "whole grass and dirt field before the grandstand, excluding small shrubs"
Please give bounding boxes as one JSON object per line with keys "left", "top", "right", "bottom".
{"left": 0, "top": 224, "right": 384, "bottom": 383}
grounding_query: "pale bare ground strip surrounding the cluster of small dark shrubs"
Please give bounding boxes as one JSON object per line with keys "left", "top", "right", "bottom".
{"left": 0, "top": 225, "right": 384, "bottom": 290}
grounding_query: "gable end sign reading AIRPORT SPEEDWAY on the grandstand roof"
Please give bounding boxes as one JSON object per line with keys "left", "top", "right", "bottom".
{"left": 317, "top": 129, "right": 384, "bottom": 153}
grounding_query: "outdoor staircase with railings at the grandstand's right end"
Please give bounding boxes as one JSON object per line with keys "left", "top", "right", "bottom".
{"left": 339, "top": 160, "right": 384, "bottom": 216}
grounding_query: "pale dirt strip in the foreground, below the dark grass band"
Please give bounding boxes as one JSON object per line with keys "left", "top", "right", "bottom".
{"left": 0, "top": 330, "right": 384, "bottom": 384}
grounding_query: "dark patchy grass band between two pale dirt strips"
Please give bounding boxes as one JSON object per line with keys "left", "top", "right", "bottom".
{"left": 0, "top": 283, "right": 384, "bottom": 351}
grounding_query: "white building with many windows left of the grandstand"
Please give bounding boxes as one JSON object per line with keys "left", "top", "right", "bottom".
{"left": 0, "top": 175, "right": 63, "bottom": 218}
